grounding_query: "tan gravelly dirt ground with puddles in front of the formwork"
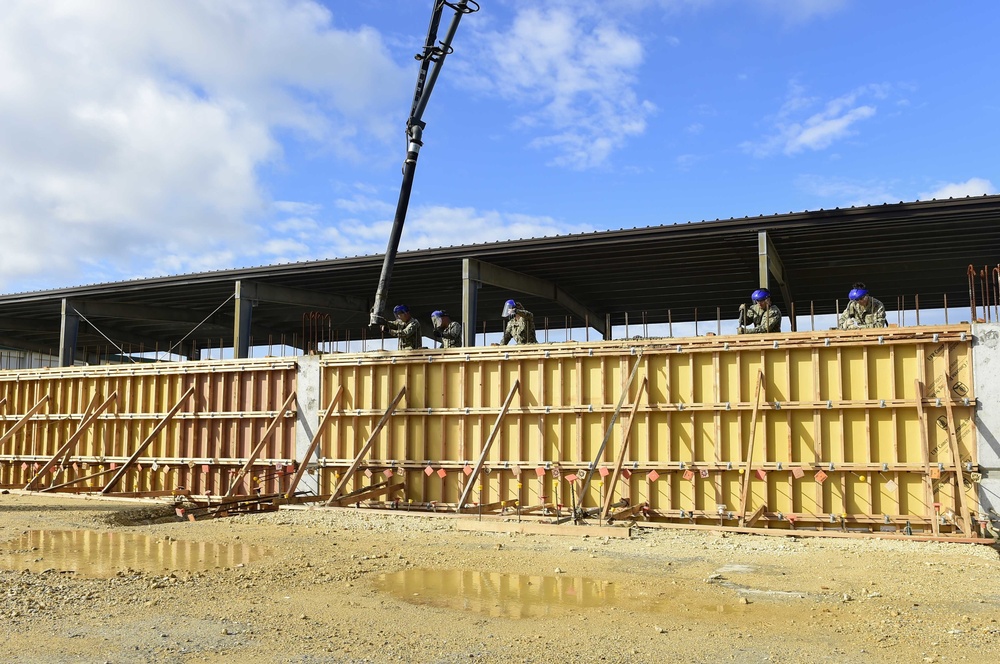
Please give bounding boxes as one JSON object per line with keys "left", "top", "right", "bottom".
{"left": 0, "top": 493, "right": 1000, "bottom": 663}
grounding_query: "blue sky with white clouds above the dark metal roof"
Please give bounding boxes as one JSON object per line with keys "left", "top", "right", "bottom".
{"left": 0, "top": 0, "right": 1000, "bottom": 293}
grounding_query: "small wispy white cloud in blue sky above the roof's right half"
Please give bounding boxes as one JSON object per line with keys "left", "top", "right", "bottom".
{"left": 741, "top": 82, "right": 889, "bottom": 157}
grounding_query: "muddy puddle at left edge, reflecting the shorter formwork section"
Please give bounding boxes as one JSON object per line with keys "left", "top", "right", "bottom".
{"left": 0, "top": 530, "right": 270, "bottom": 578}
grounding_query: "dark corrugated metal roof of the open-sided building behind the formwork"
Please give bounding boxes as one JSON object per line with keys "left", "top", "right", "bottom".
{"left": 0, "top": 196, "right": 1000, "bottom": 351}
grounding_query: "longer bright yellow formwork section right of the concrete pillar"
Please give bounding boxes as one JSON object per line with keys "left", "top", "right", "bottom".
{"left": 321, "top": 326, "right": 977, "bottom": 530}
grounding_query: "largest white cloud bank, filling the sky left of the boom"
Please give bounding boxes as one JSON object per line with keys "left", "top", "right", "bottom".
{"left": 0, "top": 0, "right": 412, "bottom": 287}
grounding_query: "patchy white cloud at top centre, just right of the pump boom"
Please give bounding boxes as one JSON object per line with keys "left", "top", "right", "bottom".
{"left": 465, "top": 1, "right": 655, "bottom": 169}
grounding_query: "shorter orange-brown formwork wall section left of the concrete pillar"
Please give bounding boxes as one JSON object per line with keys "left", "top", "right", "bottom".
{"left": 0, "top": 359, "right": 296, "bottom": 495}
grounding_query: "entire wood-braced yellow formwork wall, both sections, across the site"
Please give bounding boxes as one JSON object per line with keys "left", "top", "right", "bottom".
{"left": 0, "top": 326, "right": 978, "bottom": 533}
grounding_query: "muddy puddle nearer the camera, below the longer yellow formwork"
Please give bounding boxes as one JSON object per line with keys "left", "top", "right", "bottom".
{"left": 377, "top": 569, "right": 746, "bottom": 619}
